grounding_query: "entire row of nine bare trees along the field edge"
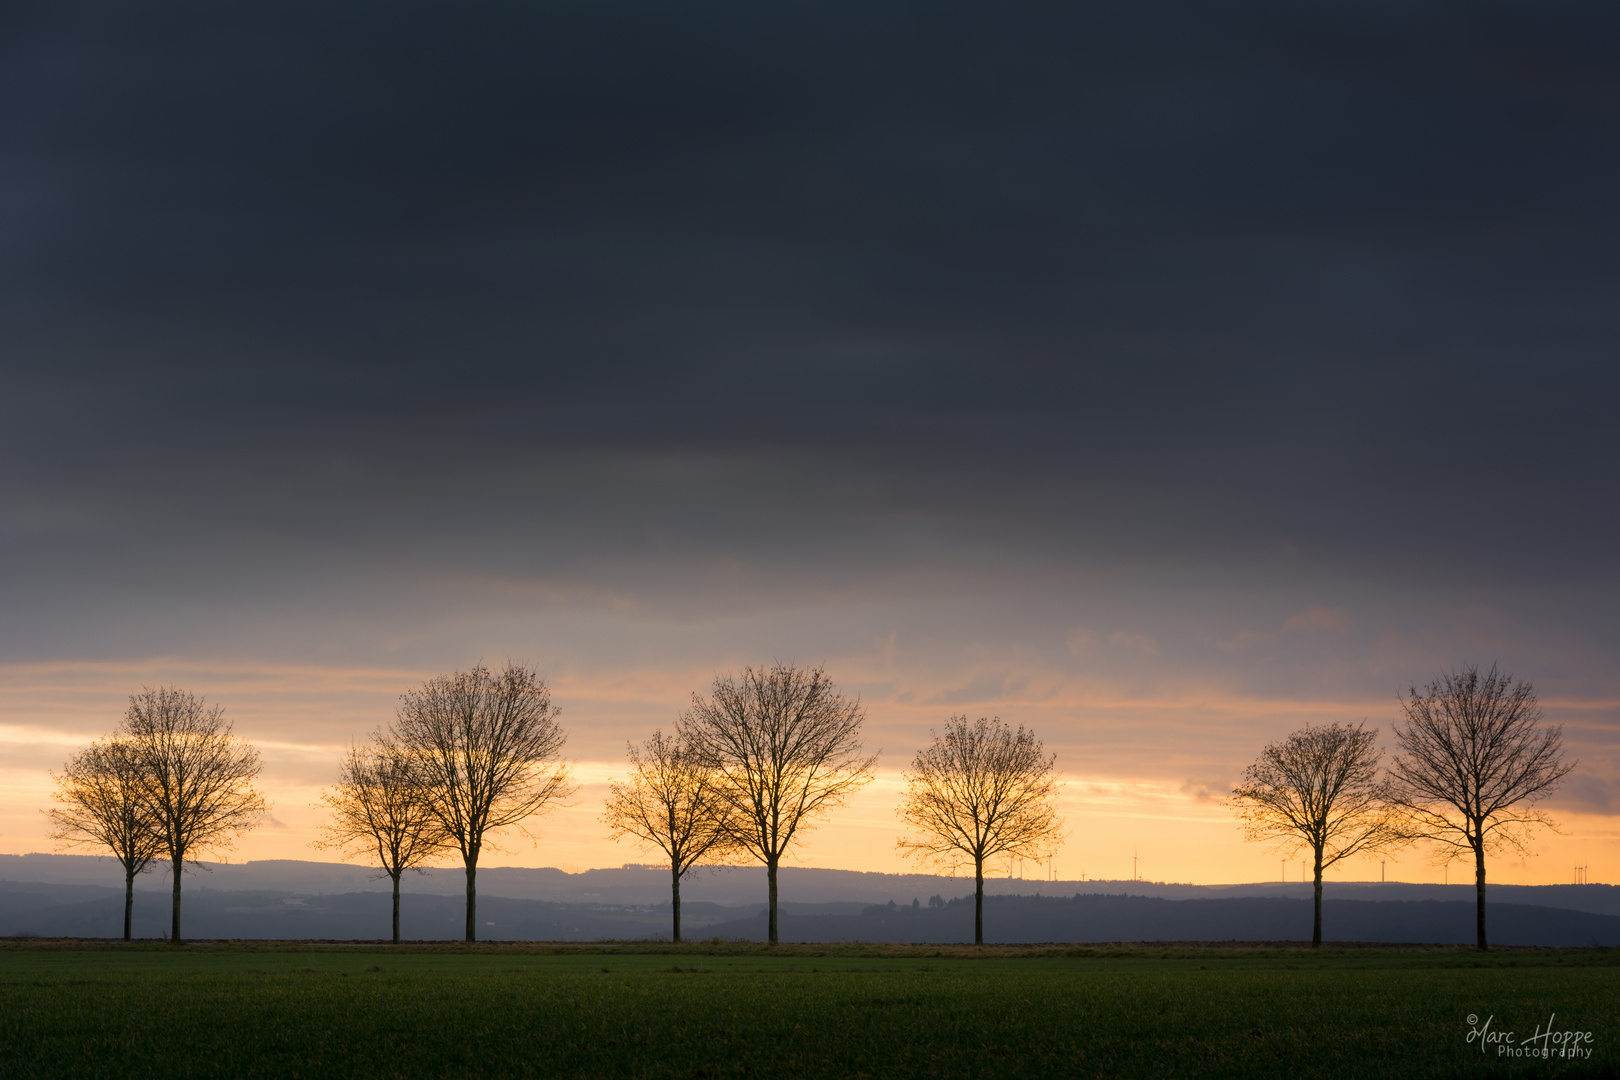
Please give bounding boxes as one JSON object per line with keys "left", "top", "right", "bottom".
{"left": 49, "top": 664, "right": 1573, "bottom": 949}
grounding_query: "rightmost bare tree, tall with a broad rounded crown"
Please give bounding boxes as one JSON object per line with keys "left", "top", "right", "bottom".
{"left": 1390, "top": 664, "right": 1576, "bottom": 949}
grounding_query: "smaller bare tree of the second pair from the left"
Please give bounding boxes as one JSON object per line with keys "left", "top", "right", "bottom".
{"left": 314, "top": 737, "right": 450, "bottom": 944}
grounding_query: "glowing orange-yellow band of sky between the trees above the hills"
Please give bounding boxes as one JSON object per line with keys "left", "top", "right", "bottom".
{"left": 0, "top": 661, "right": 1620, "bottom": 884}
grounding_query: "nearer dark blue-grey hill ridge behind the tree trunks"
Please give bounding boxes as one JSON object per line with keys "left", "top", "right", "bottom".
{"left": 0, "top": 882, "right": 1620, "bottom": 947}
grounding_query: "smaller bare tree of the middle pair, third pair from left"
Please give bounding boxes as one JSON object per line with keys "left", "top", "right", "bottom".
{"left": 603, "top": 732, "right": 737, "bottom": 941}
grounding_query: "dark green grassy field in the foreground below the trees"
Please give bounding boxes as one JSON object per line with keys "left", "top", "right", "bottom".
{"left": 0, "top": 941, "right": 1620, "bottom": 1080}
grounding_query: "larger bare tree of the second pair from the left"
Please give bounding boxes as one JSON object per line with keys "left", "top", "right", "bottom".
{"left": 387, "top": 664, "right": 573, "bottom": 941}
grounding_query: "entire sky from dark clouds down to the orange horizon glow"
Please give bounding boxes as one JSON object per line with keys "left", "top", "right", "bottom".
{"left": 0, "top": 0, "right": 1620, "bottom": 881}
